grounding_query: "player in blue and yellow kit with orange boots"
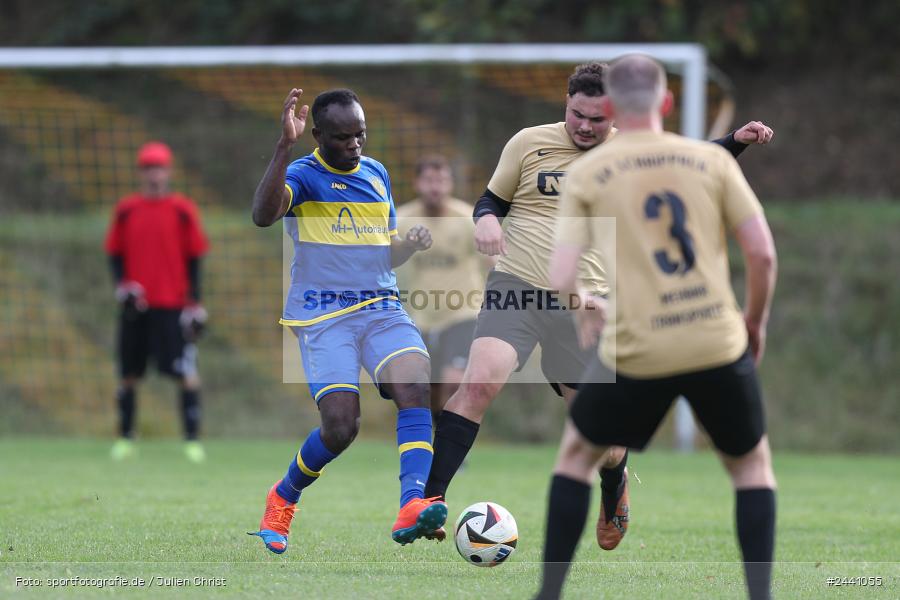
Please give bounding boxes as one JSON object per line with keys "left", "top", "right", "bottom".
{"left": 253, "top": 89, "right": 447, "bottom": 554}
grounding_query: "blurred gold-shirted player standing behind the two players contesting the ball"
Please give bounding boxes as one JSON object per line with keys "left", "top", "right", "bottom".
{"left": 397, "top": 155, "right": 493, "bottom": 418}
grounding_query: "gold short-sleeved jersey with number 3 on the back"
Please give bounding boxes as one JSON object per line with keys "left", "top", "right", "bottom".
{"left": 556, "top": 131, "right": 762, "bottom": 377}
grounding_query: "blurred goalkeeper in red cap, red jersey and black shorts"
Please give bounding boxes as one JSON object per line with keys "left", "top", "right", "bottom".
{"left": 106, "top": 142, "right": 208, "bottom": 462}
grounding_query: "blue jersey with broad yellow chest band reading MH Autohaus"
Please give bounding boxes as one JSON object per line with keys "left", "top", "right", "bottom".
{"left": 281, "top": 149, "right": 399, "bottom": 326}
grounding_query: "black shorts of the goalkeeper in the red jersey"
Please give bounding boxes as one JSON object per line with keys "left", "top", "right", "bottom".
{"left": 119, "top": 308, "right": 196, "bottom": 378}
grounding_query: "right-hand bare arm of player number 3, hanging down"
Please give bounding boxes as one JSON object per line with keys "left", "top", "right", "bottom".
{"left": 735, "top": 215, "right": 778, "bottom": 364}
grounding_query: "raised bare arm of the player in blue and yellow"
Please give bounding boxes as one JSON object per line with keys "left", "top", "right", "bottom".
{"left": 253, "top": 88, "right": 309, "bottom": 227}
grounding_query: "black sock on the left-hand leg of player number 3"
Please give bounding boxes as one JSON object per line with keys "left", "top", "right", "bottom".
{"left": 537, "top": 475, "right": 591, "bottom": 600}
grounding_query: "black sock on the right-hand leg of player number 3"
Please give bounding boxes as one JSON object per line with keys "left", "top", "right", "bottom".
{"left": 735, "top": 488, "right": 775, "bottom": 600}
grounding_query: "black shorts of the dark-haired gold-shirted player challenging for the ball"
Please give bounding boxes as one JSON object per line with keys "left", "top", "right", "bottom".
{"left": 475, "top": 270, "right": 596, "bottom": 395}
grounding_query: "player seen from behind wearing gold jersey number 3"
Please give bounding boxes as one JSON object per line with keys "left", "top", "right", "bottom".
{"left": 539, "top": 55, "right": 776, "bottom": 600}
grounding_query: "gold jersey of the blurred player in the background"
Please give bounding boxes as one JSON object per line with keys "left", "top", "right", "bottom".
{"left": 396, "top": 198, "right": 487, "bottom": 331}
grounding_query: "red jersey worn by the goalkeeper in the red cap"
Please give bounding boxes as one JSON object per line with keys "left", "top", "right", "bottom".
{"left": 106, "top": 193, "right": 209, "bottom": 308}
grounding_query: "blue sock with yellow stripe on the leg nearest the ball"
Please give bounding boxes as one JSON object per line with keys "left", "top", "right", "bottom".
{"left": 397, "top": 408, "right": 434, "bottom": 507}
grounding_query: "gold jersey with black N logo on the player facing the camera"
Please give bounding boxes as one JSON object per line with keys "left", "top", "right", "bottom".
{"left": 488, "top": 123, "right": 615, "bottom": 292}
